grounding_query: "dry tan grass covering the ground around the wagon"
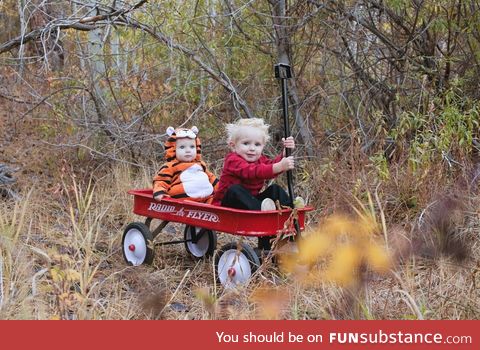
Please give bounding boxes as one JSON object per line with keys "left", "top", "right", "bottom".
{"left": 0, "top": 159, "right": 480, "bottom": 319}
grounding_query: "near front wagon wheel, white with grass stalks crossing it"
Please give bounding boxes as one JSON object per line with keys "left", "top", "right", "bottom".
{"left": 215, "top": 242, "right": 260, "bottom": 288}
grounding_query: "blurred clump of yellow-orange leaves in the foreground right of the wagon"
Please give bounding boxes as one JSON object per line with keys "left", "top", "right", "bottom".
{"left": 279, "top": 215, "right": 392, "bottom": 287}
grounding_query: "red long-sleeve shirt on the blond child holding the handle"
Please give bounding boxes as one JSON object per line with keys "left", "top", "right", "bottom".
{"left": 213, "top": 152, "right": 283, "bottom": 205}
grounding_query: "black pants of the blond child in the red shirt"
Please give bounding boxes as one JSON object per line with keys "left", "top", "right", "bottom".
{"left": 222, "top": 184, "right": 292, "bottom": 250}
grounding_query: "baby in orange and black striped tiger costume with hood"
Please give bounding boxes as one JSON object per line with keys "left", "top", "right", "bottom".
{"left": 153, "top": 126, "right": 218, "bottom": 203}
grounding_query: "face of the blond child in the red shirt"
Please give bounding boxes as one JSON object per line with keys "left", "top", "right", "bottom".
{"left": 230, "top": 127, "right": 265, "bottom": 163}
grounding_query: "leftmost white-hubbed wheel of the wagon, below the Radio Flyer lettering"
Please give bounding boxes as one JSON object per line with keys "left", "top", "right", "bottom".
{"left": 122, "top": 222, "right": 154, "bottom": 266}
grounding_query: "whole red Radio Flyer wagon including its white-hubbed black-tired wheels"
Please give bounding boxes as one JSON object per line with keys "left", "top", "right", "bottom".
{"left": 122, "top": 189, "right": 313, "bottom": 286}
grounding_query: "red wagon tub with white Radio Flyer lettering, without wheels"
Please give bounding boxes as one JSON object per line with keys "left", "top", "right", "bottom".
{"left": 128, "top": 189, "right": 313, "bottom": 237}
